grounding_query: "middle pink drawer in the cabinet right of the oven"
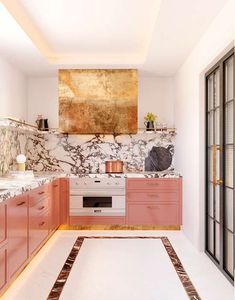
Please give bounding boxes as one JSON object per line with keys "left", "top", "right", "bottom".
{"left": 126, "top": 190, "right": 179, "bottom": 202}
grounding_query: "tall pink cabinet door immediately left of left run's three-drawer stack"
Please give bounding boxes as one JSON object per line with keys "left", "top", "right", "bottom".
{"left": 7, "top": 196, "right": 28, "bottom": 278}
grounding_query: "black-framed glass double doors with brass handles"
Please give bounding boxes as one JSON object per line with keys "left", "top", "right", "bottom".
{"left": 206, "top": 49, "right": 235, "bottom": 281}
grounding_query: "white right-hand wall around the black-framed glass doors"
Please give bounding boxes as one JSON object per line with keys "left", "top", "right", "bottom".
{"left": 175, "top": 0, "right": 235, "bottom": 250}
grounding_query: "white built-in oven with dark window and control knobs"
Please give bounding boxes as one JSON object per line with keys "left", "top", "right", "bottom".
{"left": 70, "top": 178, "right": 125, "bottom": 216}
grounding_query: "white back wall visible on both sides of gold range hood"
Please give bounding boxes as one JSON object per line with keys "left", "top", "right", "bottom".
{"left": 28, "top": 77, "right": 174, "bottom": 128}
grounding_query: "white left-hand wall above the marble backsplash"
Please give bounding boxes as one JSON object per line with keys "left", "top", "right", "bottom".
{"left": 0, "top": 57, "right": 27, "bottom": 120}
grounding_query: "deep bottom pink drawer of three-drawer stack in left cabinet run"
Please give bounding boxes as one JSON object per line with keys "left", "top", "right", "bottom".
{"left": 29, "top": 213, "right": 49, "bottom": 255}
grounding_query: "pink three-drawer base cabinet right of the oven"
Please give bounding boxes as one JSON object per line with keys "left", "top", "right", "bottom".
{"left": 126, "top": 178, "right": 182, "bottom": 226}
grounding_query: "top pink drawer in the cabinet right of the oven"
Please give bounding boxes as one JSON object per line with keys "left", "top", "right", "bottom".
{"left": 127, "top": 178, "right": 180, "bottom": 190}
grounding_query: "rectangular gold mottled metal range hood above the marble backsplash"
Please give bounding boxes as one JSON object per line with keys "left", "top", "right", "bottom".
{"left": 59, "top": 69, "right": 138, "bottom": 134}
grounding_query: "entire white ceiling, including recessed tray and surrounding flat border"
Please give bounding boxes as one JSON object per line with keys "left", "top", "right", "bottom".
{"left": 0, "top": 0, "right": 227, "bottom": 76}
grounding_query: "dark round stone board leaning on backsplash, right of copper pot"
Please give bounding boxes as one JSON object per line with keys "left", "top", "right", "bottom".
{"left": 145, "top": 146, "right": 173, "bottom": 172}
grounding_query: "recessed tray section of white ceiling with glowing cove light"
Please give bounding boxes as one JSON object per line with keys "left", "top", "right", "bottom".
{"left": 3, "top": 0, "right": 161, "bottom": 64}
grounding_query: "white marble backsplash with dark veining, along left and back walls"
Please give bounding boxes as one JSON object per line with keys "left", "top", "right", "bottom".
{"left": 0, "top": 120, "right": 175, "bottom": 174}
